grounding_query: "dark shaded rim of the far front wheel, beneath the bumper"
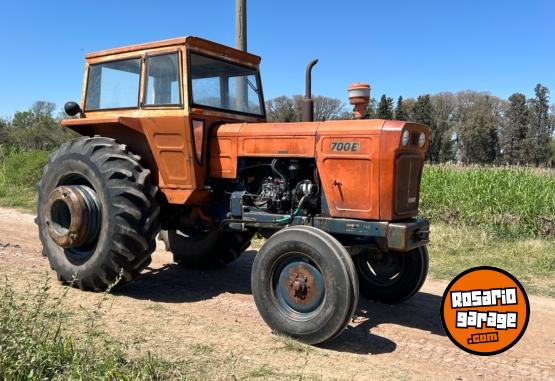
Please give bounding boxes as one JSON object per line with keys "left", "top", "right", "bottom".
{"left": 360, "top": 253, "right": 406, "bottom": 287}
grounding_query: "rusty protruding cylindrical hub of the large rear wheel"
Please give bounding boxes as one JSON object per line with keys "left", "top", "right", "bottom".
{"left": 44, "top": 185, "right": 101, "bottom": 249}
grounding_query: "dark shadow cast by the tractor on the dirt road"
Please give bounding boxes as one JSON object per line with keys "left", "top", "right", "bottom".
{"left": 118, "top": 250, "right": 445, "bottom": 354}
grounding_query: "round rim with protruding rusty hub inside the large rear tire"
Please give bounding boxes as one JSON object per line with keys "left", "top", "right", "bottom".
{"left": 43, "top": 174, "right": 102, "bottom": 262}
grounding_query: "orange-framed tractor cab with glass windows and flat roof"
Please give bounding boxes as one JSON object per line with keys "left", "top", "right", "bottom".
{"left": 70, "top": 37, "right": 265, "bottom": 120}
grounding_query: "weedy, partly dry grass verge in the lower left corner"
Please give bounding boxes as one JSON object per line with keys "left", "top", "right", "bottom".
{"left": 0, "top": 278, "right": 316, "bottom": 381}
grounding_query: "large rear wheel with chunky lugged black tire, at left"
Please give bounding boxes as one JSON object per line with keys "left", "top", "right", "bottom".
{"left": 37, "top": 137, "right": 160, "bottom": 290}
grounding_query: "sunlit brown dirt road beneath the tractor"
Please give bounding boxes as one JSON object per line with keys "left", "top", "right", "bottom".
{"left": 0, "top": 208, "right": 555, "bottom": 380}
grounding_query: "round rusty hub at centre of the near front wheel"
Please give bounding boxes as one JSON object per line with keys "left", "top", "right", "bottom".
{"left": 276, "top": 261, "right": 325, "bottom": 313}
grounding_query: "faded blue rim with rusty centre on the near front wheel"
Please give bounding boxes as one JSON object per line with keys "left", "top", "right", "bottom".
{"left": 272, "top": 253, "right": 326, "bottom": 320}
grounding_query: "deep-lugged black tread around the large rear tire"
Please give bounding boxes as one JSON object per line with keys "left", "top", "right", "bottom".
{"left": 37, "top": 136, "right": 160, "bottom": 291}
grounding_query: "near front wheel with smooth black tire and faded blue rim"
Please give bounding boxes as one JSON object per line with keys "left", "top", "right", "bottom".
{"left": 251, "top": 226, "right": 358, "bottom": 344}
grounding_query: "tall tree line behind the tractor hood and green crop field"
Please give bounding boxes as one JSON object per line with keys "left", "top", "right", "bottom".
{"left": 266, "top": 84, "right": 555, "bottom": 166}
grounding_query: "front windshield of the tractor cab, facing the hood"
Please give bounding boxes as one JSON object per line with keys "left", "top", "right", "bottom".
{"left": 189, "top": 53, "right": 264, "bottom": 116}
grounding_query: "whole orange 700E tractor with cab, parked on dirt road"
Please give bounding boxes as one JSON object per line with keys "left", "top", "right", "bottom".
{"left": 37, "top": 37, "right": 429, "bottom": 343}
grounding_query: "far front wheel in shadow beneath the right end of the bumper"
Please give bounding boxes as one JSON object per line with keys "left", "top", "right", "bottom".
{"left": 355, "top": 246, "right": 429, "bottom": 303}
